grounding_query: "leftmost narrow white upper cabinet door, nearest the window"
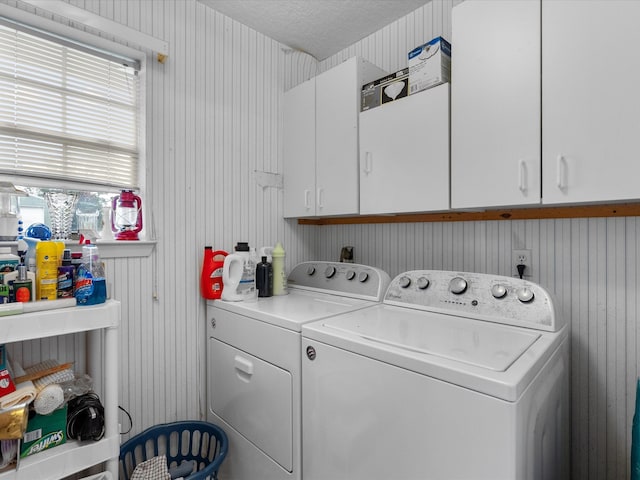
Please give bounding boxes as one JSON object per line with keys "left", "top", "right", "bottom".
{"left": 283, "top": 79, "right": 316, "bottom": 217}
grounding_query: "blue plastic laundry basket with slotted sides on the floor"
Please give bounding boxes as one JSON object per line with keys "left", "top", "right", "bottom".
{"left": 120, "top": 420, "right": 229, "bottom": 480}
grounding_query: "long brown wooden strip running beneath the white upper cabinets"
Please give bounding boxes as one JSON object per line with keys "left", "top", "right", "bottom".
{"left": 298, "top": 202, "right": 640, "bottom": 225}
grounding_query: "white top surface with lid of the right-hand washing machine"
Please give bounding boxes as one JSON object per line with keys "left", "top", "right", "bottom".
{"left": 302, "top": 304, "right": 567, "bottom": 402}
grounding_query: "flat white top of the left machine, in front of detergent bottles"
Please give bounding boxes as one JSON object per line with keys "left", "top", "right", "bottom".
{"left": 209, "top": 289, "right": 374, "bottom": 332}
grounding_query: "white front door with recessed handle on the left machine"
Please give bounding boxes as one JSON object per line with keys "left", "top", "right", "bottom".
{"left": 209, "top": 338, "right": 293, "bottom": 472}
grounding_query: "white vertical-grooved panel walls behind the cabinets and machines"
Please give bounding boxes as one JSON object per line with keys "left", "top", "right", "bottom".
{"left": 0, "top": 0, "right": 640, "bottom": 480}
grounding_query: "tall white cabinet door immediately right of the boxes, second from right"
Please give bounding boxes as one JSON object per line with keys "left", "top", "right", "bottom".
{"left": 451, "top": 0, "right": 540, "bottom": 208}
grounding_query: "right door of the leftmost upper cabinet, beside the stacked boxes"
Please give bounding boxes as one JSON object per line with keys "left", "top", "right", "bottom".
{"left": 316, "top": 57, "right": 360, "bottom": 215}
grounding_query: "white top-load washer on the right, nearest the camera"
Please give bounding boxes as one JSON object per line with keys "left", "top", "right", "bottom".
{"left": 301, "top": 270, "right": 569, "bottom": 480}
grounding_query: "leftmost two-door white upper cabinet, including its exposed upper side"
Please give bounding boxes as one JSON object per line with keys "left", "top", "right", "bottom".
{"left": 284, "top": 57, "right": 386, "bottom": 217}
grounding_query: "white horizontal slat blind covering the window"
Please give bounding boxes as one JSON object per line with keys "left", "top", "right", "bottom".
{"left": 0, "top": 24, "right": 139, "bottom": 189}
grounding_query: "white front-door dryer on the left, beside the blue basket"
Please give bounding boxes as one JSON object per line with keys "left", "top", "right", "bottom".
{"left": 207, "top": 262, "right": 390, "bottom": 480}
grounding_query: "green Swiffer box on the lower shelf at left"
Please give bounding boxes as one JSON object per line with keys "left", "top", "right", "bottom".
{"left": 20, "top": 404, "right": 67, "bottom": 458}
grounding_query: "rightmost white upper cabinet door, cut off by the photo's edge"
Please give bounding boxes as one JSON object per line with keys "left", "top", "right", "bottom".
{"left": 542, "top": 0, "right": 640, "bottom": 203}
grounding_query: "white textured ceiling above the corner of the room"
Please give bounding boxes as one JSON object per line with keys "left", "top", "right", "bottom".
{"left": 198, "top": 0, "right": 431, "bottom": 60}
